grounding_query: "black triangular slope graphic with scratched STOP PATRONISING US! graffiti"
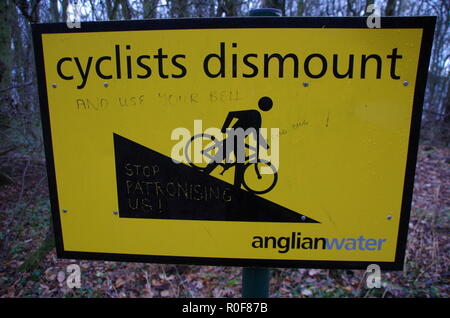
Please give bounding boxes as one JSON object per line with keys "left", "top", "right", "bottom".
{"left": 113, "top": 134, "right": 319, "bottom": 223}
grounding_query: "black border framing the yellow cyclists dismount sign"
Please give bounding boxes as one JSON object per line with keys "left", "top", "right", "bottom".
{"left": 32, "top": 16, "right": 436, "bottom": 270}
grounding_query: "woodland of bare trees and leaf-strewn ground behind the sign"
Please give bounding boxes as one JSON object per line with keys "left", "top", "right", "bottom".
{"left": 0, "top": 0, "right": 450, "bottom": 297}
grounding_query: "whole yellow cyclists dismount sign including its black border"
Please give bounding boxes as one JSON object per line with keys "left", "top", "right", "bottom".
{"left": 33, "top": 17, "right": 435, "bottom": 269}
